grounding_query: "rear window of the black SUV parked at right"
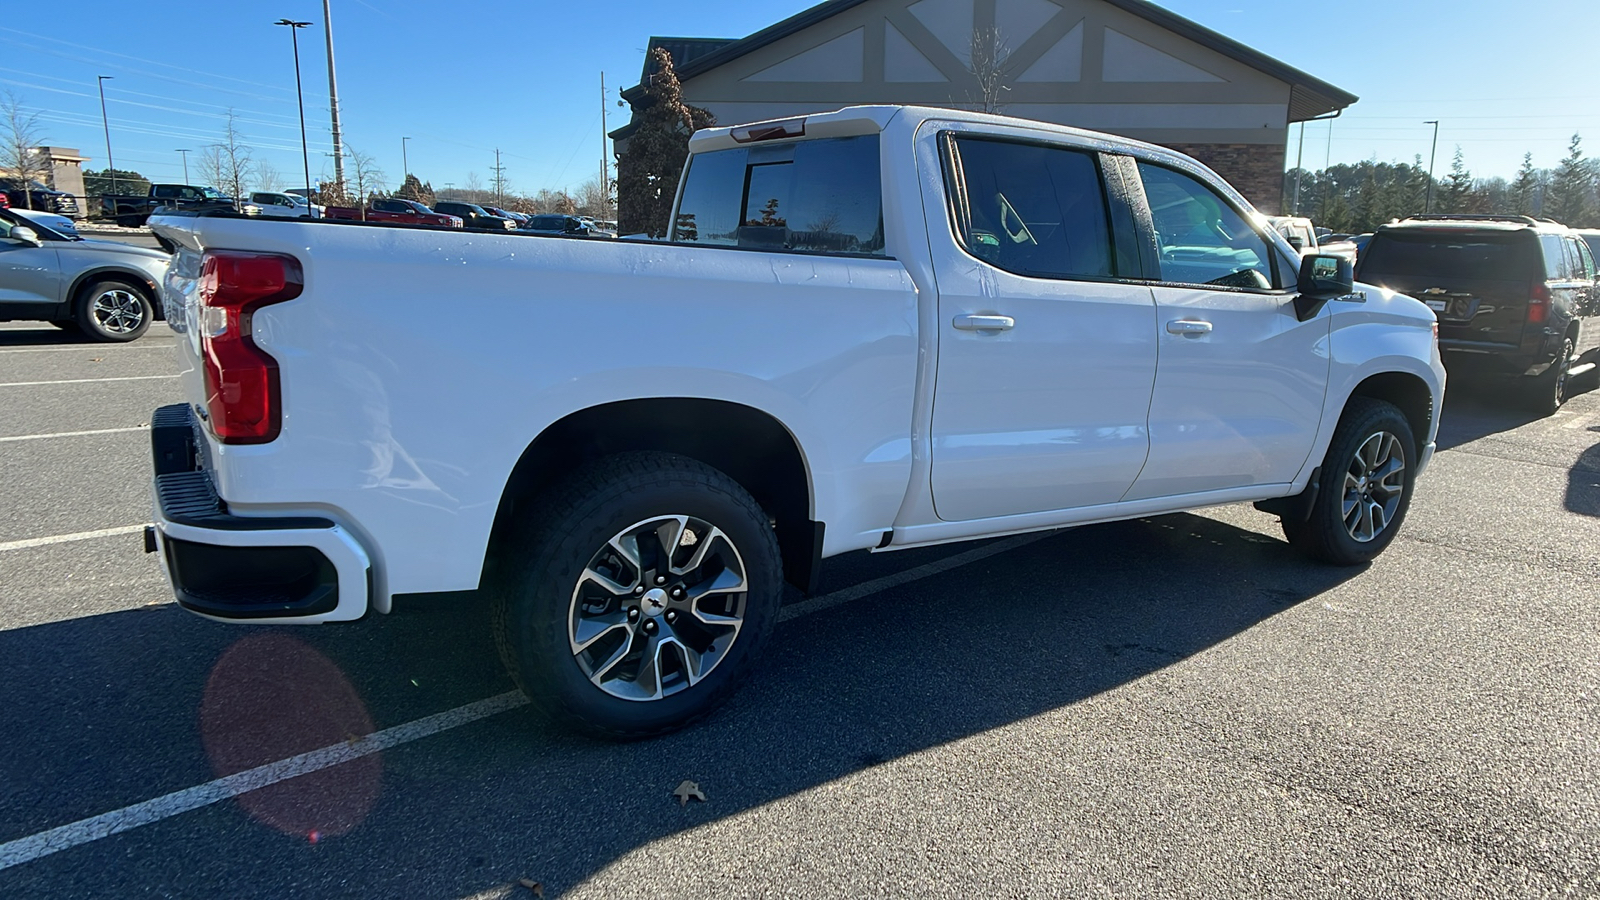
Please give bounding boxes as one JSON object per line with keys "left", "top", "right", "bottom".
{"left": 1362, "top": 231, "right": 1536, "bottom": 280}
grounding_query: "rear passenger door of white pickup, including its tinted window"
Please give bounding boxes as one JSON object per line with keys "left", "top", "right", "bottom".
{"left": 928, "top": 133, "right": 1157, "bottom": 520}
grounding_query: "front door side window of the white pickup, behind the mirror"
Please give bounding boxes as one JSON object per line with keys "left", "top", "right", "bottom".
{"left": 1139, "top": 162, "right": 1277, "bottom": 290}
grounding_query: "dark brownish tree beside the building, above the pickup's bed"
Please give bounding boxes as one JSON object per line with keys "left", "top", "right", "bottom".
{"left": 611, "top": 46, "right": 717, "bottom": 237}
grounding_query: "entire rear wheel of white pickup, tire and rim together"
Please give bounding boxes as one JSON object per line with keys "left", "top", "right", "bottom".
{"left": 493, "top": 453, "right": 782, "bottom": 738}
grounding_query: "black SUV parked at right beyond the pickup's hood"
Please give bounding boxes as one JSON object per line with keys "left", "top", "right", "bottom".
{"left": 1355, "top": 216, "right": 1600, "bottom": 415}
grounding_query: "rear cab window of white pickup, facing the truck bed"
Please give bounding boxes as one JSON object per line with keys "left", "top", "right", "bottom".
{"left": 672, "top": 135, "right": 883, "bottom": 256}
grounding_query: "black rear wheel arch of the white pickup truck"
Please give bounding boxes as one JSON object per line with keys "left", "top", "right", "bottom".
{"left": 485, "top": 397, "right": 822, "bottom": 593}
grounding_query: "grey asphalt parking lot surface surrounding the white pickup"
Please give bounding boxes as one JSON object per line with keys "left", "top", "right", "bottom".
{"left": 0, "top": 323, "right": 1600, "bottom": 898}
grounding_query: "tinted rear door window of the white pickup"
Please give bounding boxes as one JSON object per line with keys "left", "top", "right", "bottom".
{"left": 955, "top": 138, "right": 1115, "bottom": 279}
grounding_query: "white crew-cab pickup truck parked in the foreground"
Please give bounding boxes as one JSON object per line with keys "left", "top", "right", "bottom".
{"left": 147, "top": 107, "right": 1445, "bottom": 737}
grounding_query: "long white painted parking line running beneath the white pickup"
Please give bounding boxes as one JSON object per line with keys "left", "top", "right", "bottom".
{"left": 0, "top": 525, "right": 1050, "bottom": 870}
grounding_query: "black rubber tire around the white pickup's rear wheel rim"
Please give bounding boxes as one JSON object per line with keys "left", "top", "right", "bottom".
{"left": 490, "top": 453, "right": 782, "bottom": 740}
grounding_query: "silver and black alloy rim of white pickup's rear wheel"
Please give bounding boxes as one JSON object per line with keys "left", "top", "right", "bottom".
{"left": 566, "top": 516, "right": 749, "bottom": 700}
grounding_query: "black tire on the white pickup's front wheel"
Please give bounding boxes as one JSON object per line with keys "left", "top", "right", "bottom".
{"left": 1283, "top": 397, "right": 1418, "bottom": 565}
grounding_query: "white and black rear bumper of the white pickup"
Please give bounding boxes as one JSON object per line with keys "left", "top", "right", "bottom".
{"left": 147, "top": 404, "right": 371, "bottom": 625}
